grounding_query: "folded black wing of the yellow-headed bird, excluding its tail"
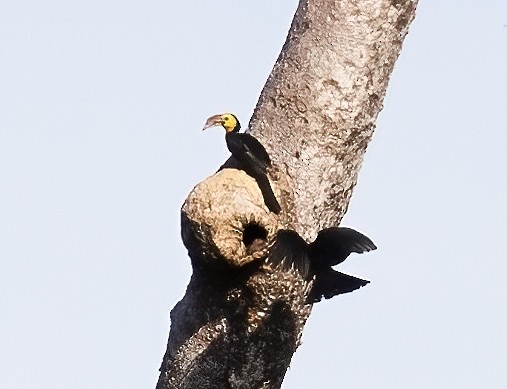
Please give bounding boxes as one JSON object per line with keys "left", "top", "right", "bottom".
{"left": 225, "top": 133, "right": 271, "bottom": 174}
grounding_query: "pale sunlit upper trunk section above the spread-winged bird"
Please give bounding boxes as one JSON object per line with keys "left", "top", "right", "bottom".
{"left": 249, "top": 0, "right": 417, "bottom": 239}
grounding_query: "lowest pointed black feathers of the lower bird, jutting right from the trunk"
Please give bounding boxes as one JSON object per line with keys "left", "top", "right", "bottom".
{"left": 308, "top": 268, "right": 370, "bottom": 303}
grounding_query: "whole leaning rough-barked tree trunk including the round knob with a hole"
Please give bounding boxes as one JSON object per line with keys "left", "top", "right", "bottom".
{"left": 157, "top": 0, "right": 417, "bottom": 389}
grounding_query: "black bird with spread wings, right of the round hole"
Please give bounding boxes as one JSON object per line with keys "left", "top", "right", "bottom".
{"left": 269, "top": 227, "right": 377, "bottom": 303}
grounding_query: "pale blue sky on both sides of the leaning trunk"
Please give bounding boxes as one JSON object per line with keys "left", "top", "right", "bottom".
{"left": 0, "top": 0, "right": 507, "bottom": 389}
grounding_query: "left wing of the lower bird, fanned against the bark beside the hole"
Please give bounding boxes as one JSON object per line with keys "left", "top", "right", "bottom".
{"left": 268, "top": 230, "right": 310, "bottom": 278}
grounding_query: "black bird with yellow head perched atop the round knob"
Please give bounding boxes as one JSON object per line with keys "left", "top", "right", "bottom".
{"left": 203, "top": 113, "right": 282, "bottom": 213}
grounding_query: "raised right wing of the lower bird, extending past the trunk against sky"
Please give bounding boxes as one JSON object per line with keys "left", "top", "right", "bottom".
{"left": 310, "top": 227, "right": 377, "bottom": 269}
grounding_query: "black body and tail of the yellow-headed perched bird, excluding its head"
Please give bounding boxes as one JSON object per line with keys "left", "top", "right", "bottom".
{"left": 225, "top": 128, "right": 281, "bottom": 213}
